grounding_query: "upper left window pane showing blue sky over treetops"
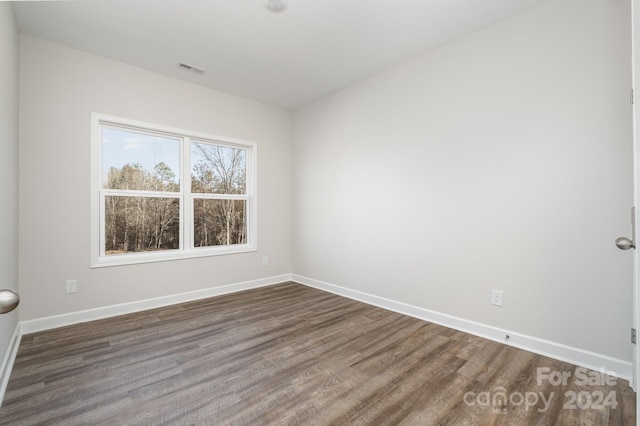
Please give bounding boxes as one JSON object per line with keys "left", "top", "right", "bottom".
{"left": 102, "top": 127, "right": 180, "bottom": 192}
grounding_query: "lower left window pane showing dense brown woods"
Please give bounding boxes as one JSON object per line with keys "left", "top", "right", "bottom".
{"left": 104, "top": 196, "right": 180, "bottom": 255}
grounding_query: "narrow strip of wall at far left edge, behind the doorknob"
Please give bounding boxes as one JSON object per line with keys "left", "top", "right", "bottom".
{"left": 0, "top": 2, "right": 19, "bottom": 364}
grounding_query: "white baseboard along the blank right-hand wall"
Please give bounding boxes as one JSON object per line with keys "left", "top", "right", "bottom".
{"left": 291, "top": 274, "right": 633, "bottom": 381}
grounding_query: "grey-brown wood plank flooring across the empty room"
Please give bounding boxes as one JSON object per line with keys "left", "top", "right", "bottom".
{"left": 0, "top": 283, "right": 636, "bottom": 425}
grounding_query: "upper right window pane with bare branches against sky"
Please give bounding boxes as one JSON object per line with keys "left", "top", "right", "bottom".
{"left": 191, "top": 142, "right": 247, "bottom": 194}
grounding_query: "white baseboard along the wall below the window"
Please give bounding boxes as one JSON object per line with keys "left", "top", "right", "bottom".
{"left": 21, "top": 274, "right": 291, "bottom": 334}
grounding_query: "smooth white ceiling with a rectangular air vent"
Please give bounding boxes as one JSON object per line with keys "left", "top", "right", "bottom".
{"left": 13, "top": 0, "right": 543, "bottom": 109}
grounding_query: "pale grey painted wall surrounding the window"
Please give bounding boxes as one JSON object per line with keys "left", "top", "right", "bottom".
{"left": 20, "top": 34, "right": 291, "bottom": 320}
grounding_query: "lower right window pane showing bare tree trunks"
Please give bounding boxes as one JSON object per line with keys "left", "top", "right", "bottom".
{"left": 193, "top": 199, "right": 247, "bottom": 247}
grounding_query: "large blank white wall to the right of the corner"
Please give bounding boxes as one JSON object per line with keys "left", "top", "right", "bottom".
{"left": 292, "top": 0, "right": 633, "bottom": 361}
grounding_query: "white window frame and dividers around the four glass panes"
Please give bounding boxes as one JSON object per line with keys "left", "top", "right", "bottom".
{"left": 91, "top": 113, "right": 258, "bottom": 268}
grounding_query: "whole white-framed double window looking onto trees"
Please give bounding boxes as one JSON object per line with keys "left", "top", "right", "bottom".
{"left": 91, "top": 114, "right": 256, "bottom": 267}
